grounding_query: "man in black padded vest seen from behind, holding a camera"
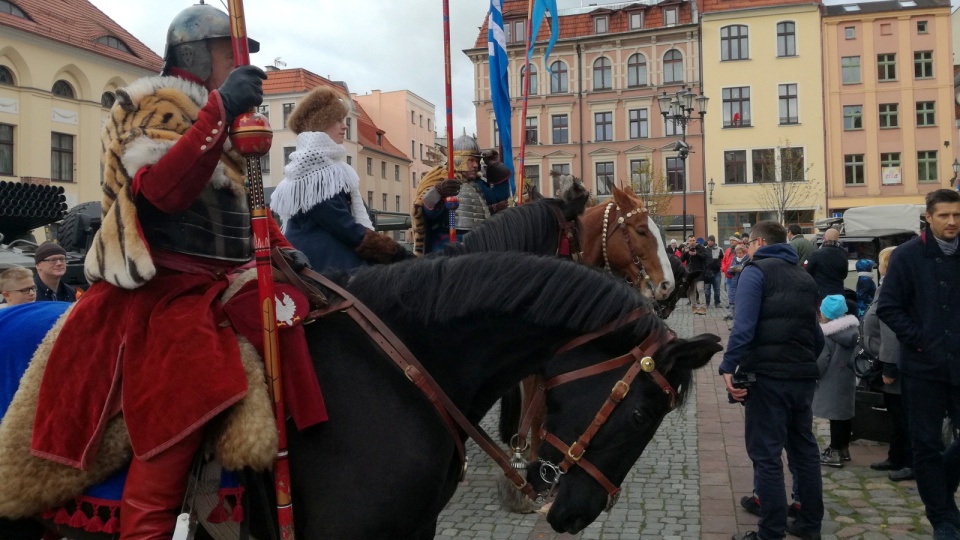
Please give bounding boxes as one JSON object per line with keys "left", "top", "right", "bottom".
{"left": 720, "top": 221, "right": 823, "bottom": 540}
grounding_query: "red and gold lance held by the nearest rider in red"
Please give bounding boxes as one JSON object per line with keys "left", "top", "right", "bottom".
{"left": 227, "top": 0, "right": 295, "bottom": 540}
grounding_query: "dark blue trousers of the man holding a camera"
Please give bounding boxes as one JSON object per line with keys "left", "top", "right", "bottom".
{"left": 744, "top": 375, "right": 823, "bottom": 540}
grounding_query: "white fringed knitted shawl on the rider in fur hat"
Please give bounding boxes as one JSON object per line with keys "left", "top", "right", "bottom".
{"left": 270, "top": 131, "right": 373, "bottom": 230}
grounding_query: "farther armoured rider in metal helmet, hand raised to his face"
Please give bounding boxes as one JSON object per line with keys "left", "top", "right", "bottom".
{"left": 413, "top": 134, "right": 510, "bottom": 255}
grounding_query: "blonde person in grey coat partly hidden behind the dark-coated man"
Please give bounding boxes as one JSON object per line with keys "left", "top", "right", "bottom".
{"left": 863, "top": 247, "right": 915, "bottom": 482}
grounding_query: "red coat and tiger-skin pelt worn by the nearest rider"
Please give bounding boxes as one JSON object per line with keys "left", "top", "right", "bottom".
{"left": 32, "top": 76, "right": 290, "bottom": 468}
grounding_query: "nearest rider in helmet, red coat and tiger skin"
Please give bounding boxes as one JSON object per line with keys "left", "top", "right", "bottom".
{"left": 17, "top": 3, "right": 325, "bottom": 540}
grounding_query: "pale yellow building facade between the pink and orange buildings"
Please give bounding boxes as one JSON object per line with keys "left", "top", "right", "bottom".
{"left": 701, "top": 0, "right": 826, "bottom": 240}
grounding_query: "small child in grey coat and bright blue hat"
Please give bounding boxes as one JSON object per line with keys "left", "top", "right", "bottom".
{"left": 813, "top": 294, "right": 860, "bottom": 467}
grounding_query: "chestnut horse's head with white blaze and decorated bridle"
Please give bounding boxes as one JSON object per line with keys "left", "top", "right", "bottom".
{"left": 580, "top": 186, "right": 675, "bottom": 300}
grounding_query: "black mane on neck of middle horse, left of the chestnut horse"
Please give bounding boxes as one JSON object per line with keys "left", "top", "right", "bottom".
{"left": 438, "top": 199, "right": 560, "bottom": 256}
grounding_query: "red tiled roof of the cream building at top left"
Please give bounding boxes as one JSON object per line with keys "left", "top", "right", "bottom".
{"left": 0, "top": 0, "right": 163, "bottom": 73}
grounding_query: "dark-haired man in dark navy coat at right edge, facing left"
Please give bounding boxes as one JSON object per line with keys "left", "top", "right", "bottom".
{"left": 877, "top": 189, "right": 960, "bottom": 540}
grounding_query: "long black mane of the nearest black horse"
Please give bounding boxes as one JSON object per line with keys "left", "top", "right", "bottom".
{"left": 347, "top": 252, "right": 661, "bottom": 340}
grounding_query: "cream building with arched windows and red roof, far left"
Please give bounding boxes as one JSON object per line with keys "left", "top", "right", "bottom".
{"left": 0, "top": 0, "right": 162, "bottom": 206}
